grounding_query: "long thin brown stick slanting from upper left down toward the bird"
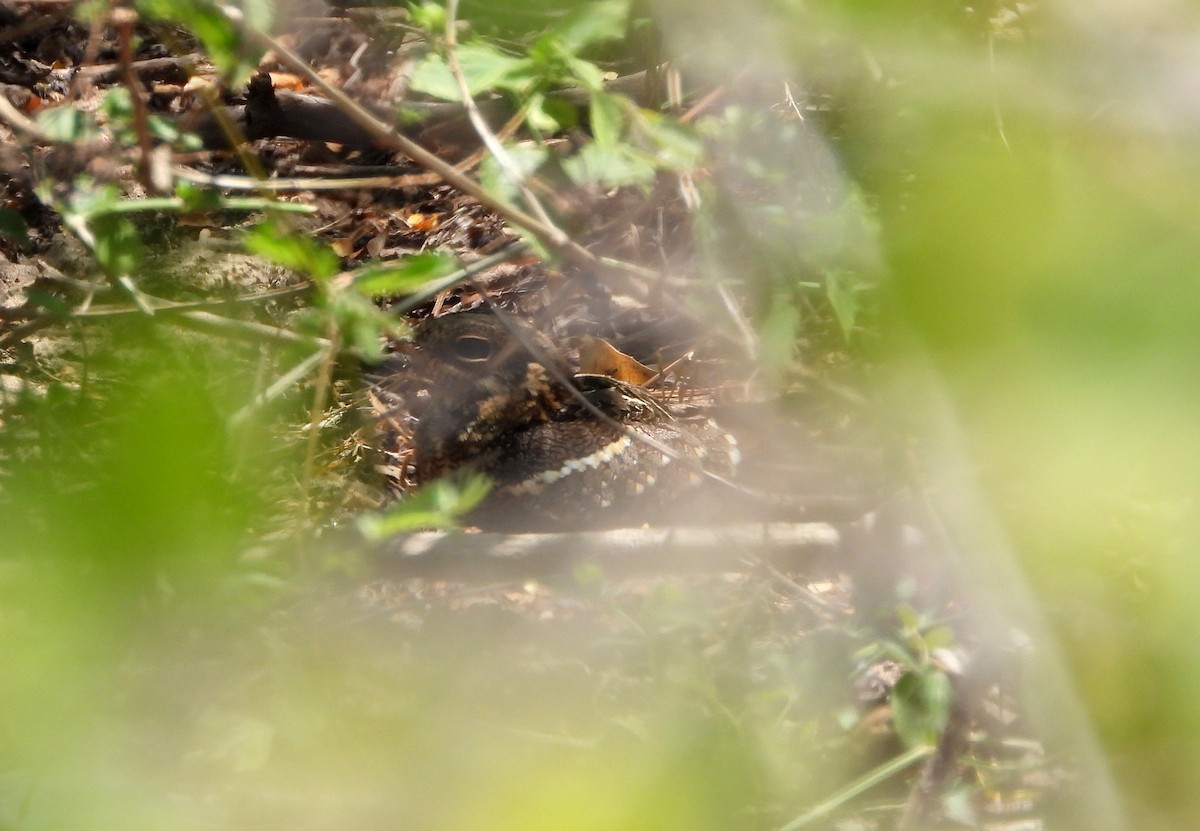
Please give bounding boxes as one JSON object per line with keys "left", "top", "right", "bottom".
{"left": 218, "top": 5, "right": 595, "bottom": 264}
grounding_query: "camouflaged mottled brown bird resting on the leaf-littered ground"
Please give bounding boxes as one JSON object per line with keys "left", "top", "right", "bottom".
{"left": 412, "top": 309, "right": 738, "bottom": 531}
